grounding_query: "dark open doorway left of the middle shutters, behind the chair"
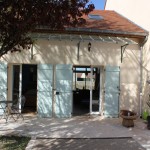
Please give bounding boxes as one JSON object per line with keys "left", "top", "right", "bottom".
{"left": 22, "top": 64, "right": 37, "bottom": 113}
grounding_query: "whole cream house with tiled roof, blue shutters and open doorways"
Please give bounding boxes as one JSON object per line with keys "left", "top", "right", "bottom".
{"left": 0, "top": 10, "right": 148, "bottom": 117}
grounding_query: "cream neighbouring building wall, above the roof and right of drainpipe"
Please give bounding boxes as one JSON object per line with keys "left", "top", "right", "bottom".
{"left": 105, "top": 0, "right": 150, "bottom": 115}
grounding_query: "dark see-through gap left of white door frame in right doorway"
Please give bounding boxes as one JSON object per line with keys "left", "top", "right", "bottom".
{"left": 73, "top": 66, "right": 91, "bottom": 115}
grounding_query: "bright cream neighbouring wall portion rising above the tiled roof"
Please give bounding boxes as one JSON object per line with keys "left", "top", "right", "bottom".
{"left": 105, "top": 0, "right": 150, "bottom": 31}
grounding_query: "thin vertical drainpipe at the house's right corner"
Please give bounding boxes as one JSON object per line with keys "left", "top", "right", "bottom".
{"left": 139, "top": 36, "right": 148, "bottom": 117}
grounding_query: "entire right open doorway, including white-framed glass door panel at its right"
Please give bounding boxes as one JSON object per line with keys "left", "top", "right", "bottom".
{"left": 73, "top": 66, "right": 100, "bottom": 115}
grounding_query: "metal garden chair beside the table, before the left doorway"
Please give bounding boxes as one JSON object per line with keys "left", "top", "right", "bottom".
{"left": 10, "top": 95, "right": 26, "bottom": 121}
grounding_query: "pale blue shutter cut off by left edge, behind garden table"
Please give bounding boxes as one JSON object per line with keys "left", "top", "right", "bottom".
{"left": 0, "top": 63, "right": 7, "bottom": 115}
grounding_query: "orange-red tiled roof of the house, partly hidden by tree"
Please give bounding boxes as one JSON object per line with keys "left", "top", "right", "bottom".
{"left": 35, "top": 10, "right": 148, "bottom": 38}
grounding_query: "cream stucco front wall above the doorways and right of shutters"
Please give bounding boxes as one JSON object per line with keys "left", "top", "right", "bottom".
{"left": 0, "top": 40, "right": 140, "bottom": 111}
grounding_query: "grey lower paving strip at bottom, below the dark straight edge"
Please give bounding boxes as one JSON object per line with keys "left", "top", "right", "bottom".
{"left": 32, "top": 137, "right": 146, "bottom": 150}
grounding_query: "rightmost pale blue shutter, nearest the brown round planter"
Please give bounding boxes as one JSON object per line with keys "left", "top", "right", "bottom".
{"left": 104, "top": 66, "right": 120, "bottom": 117}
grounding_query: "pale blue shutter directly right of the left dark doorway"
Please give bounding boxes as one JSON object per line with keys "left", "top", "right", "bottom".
{"left": 37, "top": 64, "right": 53, "bottom": 117}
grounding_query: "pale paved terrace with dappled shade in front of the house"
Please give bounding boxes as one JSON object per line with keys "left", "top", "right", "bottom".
{"left": 0, "top": 115, "right": 150, "bottom": 150}
